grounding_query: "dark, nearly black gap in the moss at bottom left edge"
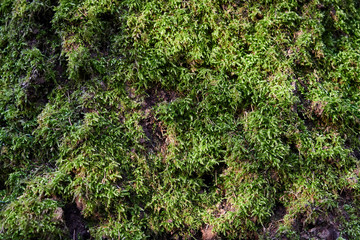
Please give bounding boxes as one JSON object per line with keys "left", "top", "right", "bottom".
{"left": 63, "top": 204, "right": 91, "bottom": 240}
